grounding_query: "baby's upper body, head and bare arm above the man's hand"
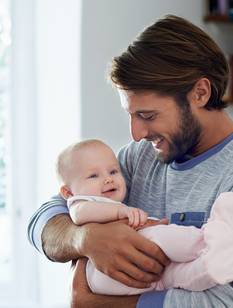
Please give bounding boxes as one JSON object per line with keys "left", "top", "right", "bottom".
{"left": 57, "top": 140, "right": 147, "bottom": 228}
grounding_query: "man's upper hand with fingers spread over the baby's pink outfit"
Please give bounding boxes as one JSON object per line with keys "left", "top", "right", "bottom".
{"left": 79, "top": 221, "right": 169, "bottom": 288}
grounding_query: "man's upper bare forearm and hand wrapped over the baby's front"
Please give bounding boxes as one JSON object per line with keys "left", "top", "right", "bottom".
{"left": 42, "top": 215, "right": 169, "bottom": 288}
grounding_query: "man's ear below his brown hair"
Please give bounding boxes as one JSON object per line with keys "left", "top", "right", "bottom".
{"left": 187, "top": 78, "right": 211, "bottom": 108}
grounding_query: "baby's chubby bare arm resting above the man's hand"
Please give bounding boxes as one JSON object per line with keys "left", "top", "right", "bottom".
{"left": 69, "top": 200, "right": 147, "bottom": 228}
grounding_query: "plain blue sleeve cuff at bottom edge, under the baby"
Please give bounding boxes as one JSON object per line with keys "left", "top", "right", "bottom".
{"left": 136, "top": 290, "right": 167, "bottom": 308}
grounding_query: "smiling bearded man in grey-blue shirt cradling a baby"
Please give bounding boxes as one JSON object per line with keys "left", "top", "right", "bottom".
{"left": 29, "top": 16, "right": 233, "bottom": 308}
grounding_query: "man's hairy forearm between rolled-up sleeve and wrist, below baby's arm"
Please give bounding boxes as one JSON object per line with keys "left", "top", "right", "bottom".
{"left": 42, "top": 214, "right": 85, "bottom": 262}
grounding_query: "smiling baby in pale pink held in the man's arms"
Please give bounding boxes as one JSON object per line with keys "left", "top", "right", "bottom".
{"left": 57, "top": 140, "right": 233, "bottom": 295}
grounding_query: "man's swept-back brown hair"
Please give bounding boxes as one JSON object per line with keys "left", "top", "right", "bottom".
{"left": 110, "top": 15, "right": 229, "bottom": 110}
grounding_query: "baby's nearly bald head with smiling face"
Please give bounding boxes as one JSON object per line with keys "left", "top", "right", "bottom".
{"left": 57, "top": 139, "right": 126, "bottom": 201}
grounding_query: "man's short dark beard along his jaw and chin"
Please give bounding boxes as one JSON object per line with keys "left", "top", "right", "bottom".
{"left": 157, "top": 104, "right": 202, "bottom": 164}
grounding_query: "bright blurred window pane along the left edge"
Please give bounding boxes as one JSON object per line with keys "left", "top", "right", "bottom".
{"left": 0, "top": 0, "right": 11, "bottom": 282}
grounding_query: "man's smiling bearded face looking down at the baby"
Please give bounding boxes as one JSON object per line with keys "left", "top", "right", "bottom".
{"left": 119, "top": 90, "right": 202, "bottom": 163}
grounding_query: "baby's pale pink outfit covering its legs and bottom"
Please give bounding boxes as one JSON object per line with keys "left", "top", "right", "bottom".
{"left": 86, "top": 192, "right": 233, "bottom": 295}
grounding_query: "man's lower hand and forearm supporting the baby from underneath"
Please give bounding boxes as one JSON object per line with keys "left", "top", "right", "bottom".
{"left": 71, "top": 258, "right": 138, "bottom": 308}
